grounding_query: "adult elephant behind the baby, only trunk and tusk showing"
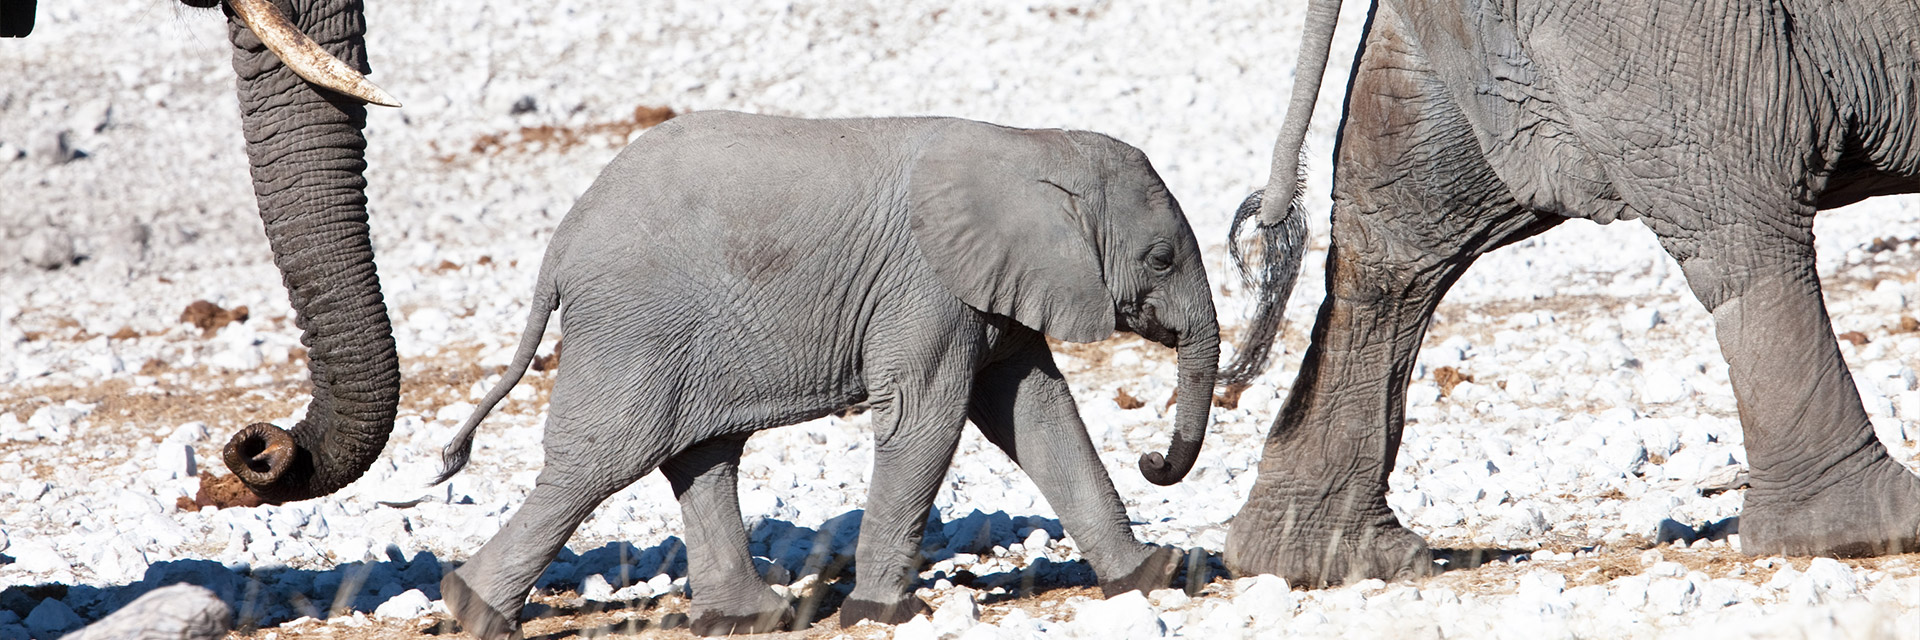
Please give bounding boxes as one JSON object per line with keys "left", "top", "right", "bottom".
{"left": 0, "top": 0, "right": 399, "bottom": 504}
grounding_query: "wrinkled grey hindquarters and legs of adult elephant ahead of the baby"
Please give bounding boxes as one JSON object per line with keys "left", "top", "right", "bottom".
{"left": 1225, "top": 0, "right": 1920, "bottom": 584}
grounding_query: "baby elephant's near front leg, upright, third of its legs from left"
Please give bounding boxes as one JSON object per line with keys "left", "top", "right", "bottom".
{"left": 839, "top": 331, "right": 977, "bottom": 618}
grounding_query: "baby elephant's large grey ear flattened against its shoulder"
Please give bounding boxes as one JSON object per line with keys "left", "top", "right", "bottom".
{"left": 908, "top": 121, "right": 1114, "bottom": 342}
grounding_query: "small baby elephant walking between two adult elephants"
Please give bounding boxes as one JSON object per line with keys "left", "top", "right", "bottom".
{"left": 442, "top": 111, "right": 1219, "bottom": 638}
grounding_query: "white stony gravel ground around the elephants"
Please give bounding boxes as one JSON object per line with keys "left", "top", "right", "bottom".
{"left": 0, "top": 0, "right": 1920, "bottom": 640}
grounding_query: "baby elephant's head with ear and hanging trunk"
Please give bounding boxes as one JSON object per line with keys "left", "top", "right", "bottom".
{"left": 910, "top": 121, "right": 1219, "bottom": 484}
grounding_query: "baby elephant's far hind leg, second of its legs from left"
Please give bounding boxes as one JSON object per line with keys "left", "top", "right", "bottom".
{"left": 660, "top": 434, "right": 793, "bottom": 636}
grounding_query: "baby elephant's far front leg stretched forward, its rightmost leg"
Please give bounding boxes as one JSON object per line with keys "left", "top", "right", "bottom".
{"left": 968, "top": 329, "right": 1179, "bottom": 596}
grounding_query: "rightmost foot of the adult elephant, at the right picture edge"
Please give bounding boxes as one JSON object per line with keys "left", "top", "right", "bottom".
{"left": 1740, "top": 457, "right": 1920, "bottom": 557}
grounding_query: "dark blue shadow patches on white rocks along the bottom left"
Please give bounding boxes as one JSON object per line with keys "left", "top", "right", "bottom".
{"left": 0, "top": 509, "right": 1152, "bottom": 640}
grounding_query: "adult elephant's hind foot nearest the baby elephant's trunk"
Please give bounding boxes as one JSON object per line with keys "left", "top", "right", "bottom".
{"left": 1221, "top": 499, "right": 1434, "bottom": 588}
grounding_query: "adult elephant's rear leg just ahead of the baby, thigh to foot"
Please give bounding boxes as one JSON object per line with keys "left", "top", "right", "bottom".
{"left": 1225, "top": 13, "right": 1561, "bottom": 586}
